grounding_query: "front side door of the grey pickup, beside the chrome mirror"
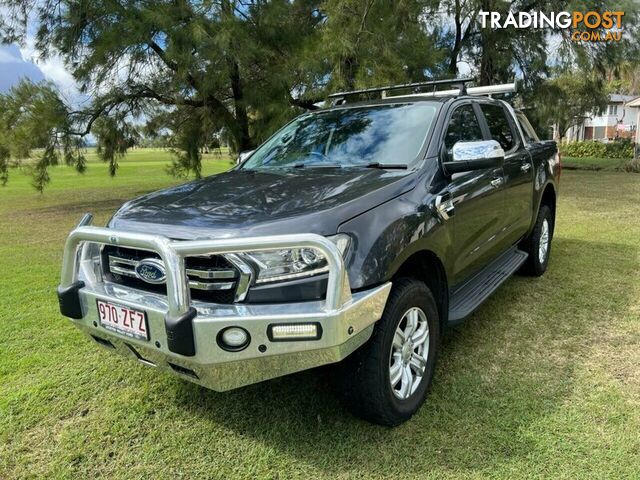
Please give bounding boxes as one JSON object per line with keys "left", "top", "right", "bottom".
{"left": 442, "top": 100, "right": 504, "bottom": 285}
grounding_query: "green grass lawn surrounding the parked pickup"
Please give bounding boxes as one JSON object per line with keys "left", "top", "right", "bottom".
{"left": 0, "top": 155, "right": 640, "bottom": 479}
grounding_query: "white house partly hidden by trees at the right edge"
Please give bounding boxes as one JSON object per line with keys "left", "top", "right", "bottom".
{"left": 565, "top": 94, "right": 638, "bottom": 143}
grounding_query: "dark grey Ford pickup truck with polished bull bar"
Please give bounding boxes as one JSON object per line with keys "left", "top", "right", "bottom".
{"left": 57, "top": 79, "right": 561, "bottom": 425}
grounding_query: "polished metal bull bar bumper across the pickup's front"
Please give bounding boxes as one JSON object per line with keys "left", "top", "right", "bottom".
{"left": 58, "top": 216, "right": 391, "bottom": 391}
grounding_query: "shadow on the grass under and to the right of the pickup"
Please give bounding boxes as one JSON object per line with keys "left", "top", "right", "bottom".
{"left": 168, "top": 238, "right": 640, "bottom": 477}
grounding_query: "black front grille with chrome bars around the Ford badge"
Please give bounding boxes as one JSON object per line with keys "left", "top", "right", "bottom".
{"left": 102, "top": 245, "right": 240, "bottom": 303}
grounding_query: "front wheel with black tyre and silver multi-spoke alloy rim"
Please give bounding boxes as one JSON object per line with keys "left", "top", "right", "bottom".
{"left": 336, "top": 278, "right": 440, "bottom": 426}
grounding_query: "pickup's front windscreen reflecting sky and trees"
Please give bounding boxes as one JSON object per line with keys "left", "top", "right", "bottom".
{"left": 242, "top": 102, "right": 437, "bottom": 169}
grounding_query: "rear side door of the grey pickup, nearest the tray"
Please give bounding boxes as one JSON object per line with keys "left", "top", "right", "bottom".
{"left": 480, "top": 102, "right": 534, "bottom": 244}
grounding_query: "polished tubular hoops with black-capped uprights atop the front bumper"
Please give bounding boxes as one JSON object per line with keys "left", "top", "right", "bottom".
{"left": 58, "top": 215, "right": 351, "bottom": 356}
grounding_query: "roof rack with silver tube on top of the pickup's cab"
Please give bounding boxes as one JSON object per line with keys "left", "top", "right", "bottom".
{"left": 329, "top": 78, "right": 518, "bottom": 105}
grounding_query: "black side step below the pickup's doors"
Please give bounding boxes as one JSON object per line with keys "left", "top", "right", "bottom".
{"left": 449, "top": 247, "right": 528, "bottom": 324}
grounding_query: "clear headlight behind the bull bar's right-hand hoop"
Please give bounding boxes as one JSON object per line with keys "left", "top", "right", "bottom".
{"left": 243, "top": 233, "right": 350, "bottom": 284}
